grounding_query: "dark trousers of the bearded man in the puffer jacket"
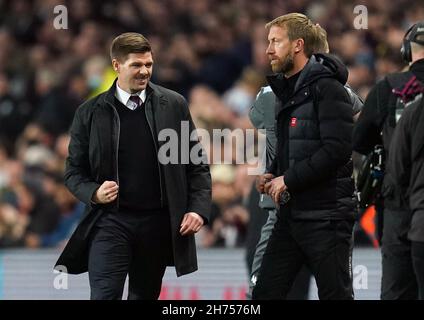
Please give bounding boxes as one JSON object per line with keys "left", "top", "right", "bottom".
{"left": 252, "top": 210, "right": 354, "bottom": 300}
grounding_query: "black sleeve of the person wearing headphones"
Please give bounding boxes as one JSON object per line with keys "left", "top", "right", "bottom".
{"left": 352, "top": 80, "right": 390, "bottom": 155}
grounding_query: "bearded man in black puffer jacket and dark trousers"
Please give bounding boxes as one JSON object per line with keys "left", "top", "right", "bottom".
{"left": 252, "top": 13, "right": 355, "bottom": 299}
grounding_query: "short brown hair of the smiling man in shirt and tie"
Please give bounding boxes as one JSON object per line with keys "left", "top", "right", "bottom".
{"left": 110, "top": 32, "right": 152, "bottom": 62}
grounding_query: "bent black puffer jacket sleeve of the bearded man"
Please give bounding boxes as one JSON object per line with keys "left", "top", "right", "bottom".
{"left": 284, "top": 79, "right": 353, "bottom": 191}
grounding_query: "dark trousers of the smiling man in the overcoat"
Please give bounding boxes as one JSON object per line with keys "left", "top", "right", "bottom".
{"left": 88, "top": 210, "right": 172, "bottom": 300}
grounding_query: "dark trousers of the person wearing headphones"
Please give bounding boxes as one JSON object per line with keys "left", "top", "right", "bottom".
{"left": 381, "top": 209, "right": 418, "bottom": 300}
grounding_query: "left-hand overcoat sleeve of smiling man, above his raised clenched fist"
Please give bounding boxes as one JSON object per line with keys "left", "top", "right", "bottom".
{"left": 64, "top": 107, "right": 100, "bottom": 205}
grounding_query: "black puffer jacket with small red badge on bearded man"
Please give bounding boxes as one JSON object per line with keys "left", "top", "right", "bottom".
{"left": 268, "top": 54, "right": 355, "bottom": 219}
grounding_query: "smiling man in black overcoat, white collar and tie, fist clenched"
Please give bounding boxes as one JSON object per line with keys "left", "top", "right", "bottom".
{"left": 56, "top": 33, "right": 211, "bottom": 299}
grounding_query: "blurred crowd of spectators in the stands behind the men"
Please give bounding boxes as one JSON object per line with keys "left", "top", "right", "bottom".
{"left": 0, "top": 0, "right": 424, "bottom": 248}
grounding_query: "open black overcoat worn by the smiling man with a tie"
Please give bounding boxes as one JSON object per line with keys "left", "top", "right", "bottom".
{"left": 56, "top": 81, "right": 211, "bottom": 276}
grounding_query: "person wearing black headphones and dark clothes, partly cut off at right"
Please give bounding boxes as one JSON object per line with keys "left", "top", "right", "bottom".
{"left": 353, "top": 22, "right": 424, "bottom": 300}
